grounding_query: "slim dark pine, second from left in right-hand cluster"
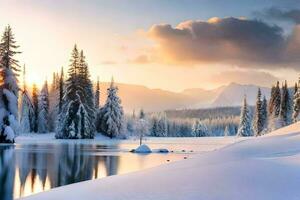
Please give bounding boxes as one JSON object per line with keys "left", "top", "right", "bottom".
{"left": 252, "top": 88, "right": 264, "bottom": 136}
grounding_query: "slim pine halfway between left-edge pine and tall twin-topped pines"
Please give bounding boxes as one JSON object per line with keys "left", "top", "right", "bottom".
{"left": 37, "top": 81, "right": 49, "bottom": 133}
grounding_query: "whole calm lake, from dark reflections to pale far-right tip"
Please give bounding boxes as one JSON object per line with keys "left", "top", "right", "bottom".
{"left": 0, "top": 135, "right": 239, "bottom": 200}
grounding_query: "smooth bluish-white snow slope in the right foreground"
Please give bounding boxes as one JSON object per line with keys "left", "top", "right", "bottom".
{"left": 24, "top": 123, "right": 300, "bottom": 200}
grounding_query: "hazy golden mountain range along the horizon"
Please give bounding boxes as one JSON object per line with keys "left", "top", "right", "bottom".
{"left": 100, "top": 83, "right": 270, "bottom": 113}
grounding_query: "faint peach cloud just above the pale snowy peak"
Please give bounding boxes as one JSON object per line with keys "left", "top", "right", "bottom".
{"left": 210, "top": 70, "right": 279, "bottom": 87}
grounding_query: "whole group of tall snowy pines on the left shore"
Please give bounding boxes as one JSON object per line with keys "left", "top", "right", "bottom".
{"left": 0, "top": 26, "right": 125, "bottom": 143}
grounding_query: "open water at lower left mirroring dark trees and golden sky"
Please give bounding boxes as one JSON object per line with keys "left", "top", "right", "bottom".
{"left": 0, "top": 144, "right": 190, "bottom": 200}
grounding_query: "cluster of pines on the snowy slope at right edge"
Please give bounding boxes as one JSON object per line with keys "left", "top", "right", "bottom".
{"left": 237, "top": 81, "right": 300, "bottom": 136}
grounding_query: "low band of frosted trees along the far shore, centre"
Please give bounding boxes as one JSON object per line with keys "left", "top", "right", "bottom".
{"left": 126, "top": 111, "right": 239, "bottom": 137}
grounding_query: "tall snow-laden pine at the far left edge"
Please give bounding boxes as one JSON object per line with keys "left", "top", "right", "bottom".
{"left": 0, "top": 25, "right": 20, "bottom": 142}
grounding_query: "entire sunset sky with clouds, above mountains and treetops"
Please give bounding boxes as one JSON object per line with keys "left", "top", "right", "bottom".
{"left": 0, "top": 0, "right": 300, "bottom": 91}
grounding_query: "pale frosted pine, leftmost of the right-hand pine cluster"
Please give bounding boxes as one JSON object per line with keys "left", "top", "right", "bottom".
{"left": 237, "top": 96, "right": 251, "bottom": 137}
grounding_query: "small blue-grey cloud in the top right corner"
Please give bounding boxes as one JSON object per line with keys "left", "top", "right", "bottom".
{"left": 255, "top": 7, "right": 300, "bottom": 24}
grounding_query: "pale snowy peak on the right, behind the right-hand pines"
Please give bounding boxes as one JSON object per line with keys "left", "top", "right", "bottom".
{"left": 212, "top": 83, "right": 270, "bottom": 107}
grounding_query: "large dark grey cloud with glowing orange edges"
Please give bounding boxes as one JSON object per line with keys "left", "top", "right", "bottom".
{"left": 148, "top": 17, "right": 300, "bottom": 68}
